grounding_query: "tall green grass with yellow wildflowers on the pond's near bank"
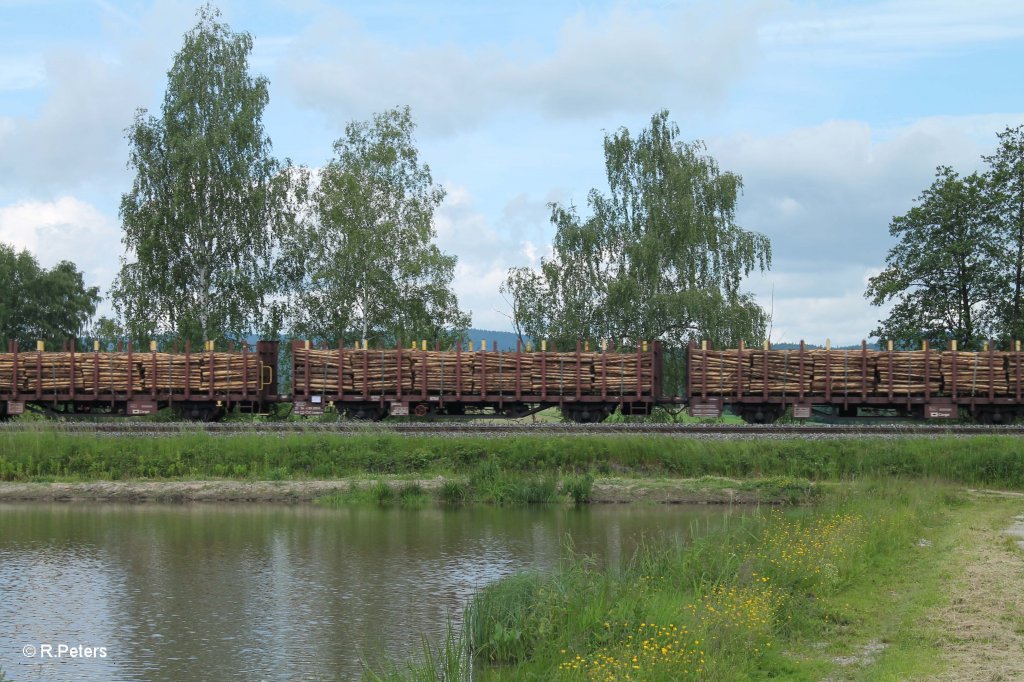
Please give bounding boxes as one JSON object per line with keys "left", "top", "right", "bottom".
{"left": 454, "top": 481, "right": 954, "bottom": 680}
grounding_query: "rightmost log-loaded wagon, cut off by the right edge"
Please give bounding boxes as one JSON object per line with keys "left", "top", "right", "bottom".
{"left": 686, "top": 341, "right": 1024, "bottom": 424}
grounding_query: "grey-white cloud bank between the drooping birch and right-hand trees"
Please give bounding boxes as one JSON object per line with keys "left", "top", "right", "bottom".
{"left": 709, "top": 114, "right": 1024, "bottom": 344}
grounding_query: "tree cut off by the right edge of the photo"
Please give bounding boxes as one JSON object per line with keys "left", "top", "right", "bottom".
{"left": 983, "top": 126, "right": 1024, "bottom": 339}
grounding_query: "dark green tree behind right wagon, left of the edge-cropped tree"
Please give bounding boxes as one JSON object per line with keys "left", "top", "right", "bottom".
{"left": 864, "top": 166, "right": 1005, "bottom": 349}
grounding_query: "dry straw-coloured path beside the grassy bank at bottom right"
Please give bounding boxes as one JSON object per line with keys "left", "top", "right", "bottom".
{"left": 928, "top": 497, "right": 1024, "bottom": 682}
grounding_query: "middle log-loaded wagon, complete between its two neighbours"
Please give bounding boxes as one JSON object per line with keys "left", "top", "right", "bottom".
{"left": 291, "top": 341, "right": 664, "bottom": 422}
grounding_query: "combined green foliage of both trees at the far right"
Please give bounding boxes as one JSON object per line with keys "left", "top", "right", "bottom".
{"left": 865, "top": 126, "right": 1024, "bottom": 349}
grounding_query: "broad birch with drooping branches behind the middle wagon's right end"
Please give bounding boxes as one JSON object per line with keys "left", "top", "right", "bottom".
{"left": 503, "top": 111, "right": 771, "bottom": 347}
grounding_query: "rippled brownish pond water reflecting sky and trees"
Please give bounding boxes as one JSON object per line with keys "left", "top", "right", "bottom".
{"left": 0, "top": 497, "right": 741, "bottom": 681}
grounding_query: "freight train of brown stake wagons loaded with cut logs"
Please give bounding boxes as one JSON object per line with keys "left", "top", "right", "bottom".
{"left": 0, "top": 333, "right": 1024, "bottom": 423}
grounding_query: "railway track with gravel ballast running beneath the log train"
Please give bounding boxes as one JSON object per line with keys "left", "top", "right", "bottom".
{"left": 0, "top": 422, "right": 1024, "bottom": 438}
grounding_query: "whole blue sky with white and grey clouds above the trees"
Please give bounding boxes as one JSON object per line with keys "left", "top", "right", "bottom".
{"left": 0, "top": 0, "right": 1024, "bottom": 344}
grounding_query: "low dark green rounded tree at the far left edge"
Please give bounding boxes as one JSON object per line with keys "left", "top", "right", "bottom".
{"left": 0, "top": 244, "right": 100, "bottom": 350}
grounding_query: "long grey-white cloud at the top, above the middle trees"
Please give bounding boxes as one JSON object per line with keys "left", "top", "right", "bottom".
{"left": 283, "top": 5, "right": 760, "bottom": 133}
